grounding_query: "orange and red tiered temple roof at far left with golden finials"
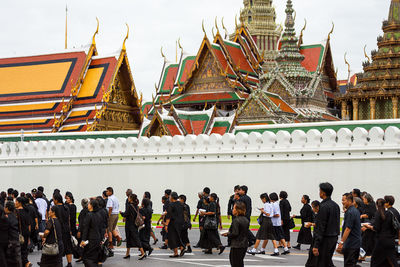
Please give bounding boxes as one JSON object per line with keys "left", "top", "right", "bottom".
{"left": 0, "top": 24, "right": 141, "bottom": 133}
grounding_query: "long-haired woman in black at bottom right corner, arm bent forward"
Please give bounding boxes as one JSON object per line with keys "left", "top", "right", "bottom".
{"left": 366, "top": 198, "right": 399, "bottom": 267}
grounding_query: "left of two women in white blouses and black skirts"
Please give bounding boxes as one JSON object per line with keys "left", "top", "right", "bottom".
{"left": 247, "top": 193, "right": 275, "bottom": 255}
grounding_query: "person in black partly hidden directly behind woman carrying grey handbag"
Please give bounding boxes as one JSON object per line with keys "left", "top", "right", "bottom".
{"left": 53, "top": 194, "right": 72, "bottom": 267}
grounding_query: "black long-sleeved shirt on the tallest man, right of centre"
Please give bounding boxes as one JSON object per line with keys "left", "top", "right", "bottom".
{"left": 314, "top": 198, "right": 340, "bottom": 248}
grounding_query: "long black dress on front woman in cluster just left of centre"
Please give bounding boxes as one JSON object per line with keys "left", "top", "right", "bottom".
{"left": 167, "top": 201, "right": 185, "bottom": 249}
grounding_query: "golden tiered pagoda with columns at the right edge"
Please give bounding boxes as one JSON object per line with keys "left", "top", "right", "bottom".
{"left": 337, "top": 0, "right": 400, "bottom": 120}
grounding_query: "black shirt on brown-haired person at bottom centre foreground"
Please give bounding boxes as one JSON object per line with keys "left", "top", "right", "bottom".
{"left": 228, "top": 216, "right": 250, "bottom": 248}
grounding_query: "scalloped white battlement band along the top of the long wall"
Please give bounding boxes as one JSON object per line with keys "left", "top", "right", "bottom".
{"left": 0, "top": 126, "right": 400, "bottom": 167}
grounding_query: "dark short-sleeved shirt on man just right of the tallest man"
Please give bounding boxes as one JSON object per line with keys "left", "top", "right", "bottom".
{"left": 342, "top": 206, "right": 361, "bottom": 249}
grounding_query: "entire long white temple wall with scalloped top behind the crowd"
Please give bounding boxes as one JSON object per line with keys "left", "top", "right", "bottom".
{"left": 0, "top": 126, "right": 400, "bottom": 214}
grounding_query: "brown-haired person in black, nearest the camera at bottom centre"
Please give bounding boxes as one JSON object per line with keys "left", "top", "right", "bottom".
{"left": 224, "top": 202, "right": 250, "bottom": 267}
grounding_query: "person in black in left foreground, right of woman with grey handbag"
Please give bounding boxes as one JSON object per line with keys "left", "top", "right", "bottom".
{"left": 80, "top": 199, "right": 101, "bottom": 267}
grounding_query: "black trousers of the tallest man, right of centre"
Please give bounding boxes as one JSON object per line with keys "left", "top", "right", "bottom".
{"left": 306, "top": 236, "right": 338, "bottom": 267}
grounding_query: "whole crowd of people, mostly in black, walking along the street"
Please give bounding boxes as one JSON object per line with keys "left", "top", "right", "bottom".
{"left": 0, "top": 183, "right": 400, "bottom": 267}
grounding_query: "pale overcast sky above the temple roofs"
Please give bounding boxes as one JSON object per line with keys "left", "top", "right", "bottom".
{"left": 0, "top": 0, "right": 390, "bottom": 100}
